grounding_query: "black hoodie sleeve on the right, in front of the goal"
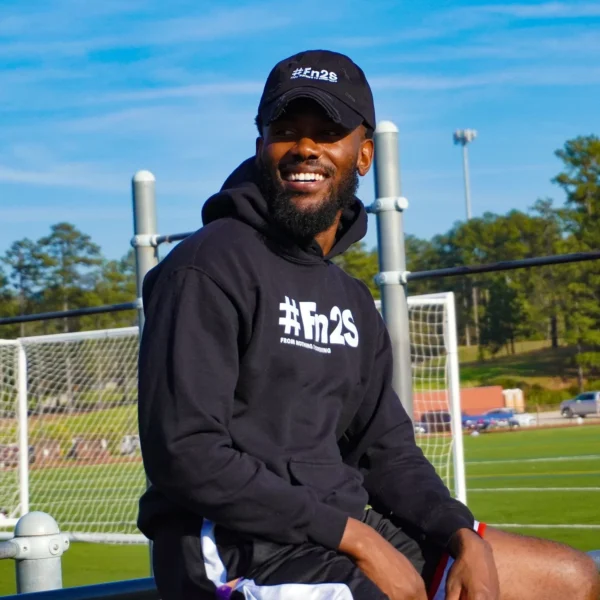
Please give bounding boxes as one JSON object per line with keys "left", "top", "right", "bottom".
{"left": 345, "top": 319, "right": 474, "bottom": 548}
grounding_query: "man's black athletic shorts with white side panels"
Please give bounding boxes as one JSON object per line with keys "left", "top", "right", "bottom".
{"left": 153, "top": 510, "right": 486, "bottom": 600}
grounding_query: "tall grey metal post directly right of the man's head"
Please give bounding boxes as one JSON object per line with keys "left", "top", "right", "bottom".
{"left": 369, "top": 121, "right": 413, "bottom": 419}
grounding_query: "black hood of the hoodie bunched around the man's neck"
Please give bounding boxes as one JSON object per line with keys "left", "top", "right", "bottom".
{"left": 202, "top": 157, "right": 367, "bottom": 262}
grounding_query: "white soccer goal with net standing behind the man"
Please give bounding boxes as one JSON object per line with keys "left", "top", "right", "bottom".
{"left": 0, "top": 293, "right": 466, "bottom": 543}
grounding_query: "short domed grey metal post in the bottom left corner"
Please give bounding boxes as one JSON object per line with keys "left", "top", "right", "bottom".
{"left": 12, "top": 511, "right": 69, "bottom": 594}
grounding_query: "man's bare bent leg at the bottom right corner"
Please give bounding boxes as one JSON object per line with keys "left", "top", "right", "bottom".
{"left": 484, "top": 527, "right": 600, "bottom": 600}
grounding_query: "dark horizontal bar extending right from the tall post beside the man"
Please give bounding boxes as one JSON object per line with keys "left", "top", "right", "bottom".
{"left": 406, "top": 250, "right": 600, "bottom": 281}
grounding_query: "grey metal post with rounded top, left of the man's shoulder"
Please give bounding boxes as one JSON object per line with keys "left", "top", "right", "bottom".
{"left": 132, "top": 171, "right": 158, "bottom": 334}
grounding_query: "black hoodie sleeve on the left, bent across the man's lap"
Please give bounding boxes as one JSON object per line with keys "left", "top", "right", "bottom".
{"left": 139, "top": 268, "right": 347, "bottom": 548}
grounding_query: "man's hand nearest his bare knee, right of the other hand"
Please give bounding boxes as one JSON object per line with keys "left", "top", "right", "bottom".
{"left": 446, "top": 529, "right": 500, "bottom": 600}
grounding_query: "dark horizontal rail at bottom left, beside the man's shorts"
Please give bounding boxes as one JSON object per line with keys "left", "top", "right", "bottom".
{"left": 2, "top": 577, "right": 160, "bottom": 600}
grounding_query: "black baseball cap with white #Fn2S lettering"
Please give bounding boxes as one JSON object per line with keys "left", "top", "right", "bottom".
{"left": 257, "top": 50, "right": 375, "bottom": 130}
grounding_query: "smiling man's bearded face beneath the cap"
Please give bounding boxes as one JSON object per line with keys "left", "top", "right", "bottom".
{"left": 256, "top": 100, "right": 373, "bottom": 238}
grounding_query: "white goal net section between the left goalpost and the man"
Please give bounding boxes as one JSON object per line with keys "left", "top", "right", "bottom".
{"left": 0, "top": 327, "right": 145, "bottom": 542}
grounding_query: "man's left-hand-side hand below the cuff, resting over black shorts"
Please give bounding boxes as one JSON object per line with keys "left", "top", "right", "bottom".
{"left": 339, "top": 518, "right": 427, "bottom": 600}
